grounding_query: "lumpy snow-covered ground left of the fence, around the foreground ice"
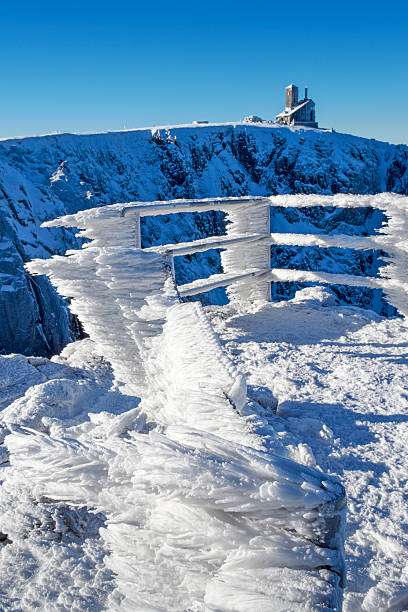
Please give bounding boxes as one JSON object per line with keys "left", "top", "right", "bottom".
{"left": 0, "top": 340, "right": 140, "bottom": 612}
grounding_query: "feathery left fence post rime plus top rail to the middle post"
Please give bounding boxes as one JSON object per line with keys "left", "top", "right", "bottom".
{"left": 27, "top": 198, "right": 263, "bottom": 396}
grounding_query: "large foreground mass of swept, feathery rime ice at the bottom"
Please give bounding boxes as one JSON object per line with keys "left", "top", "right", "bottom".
{"left": 6, "top": 426, "right": 344, "bottom": 612}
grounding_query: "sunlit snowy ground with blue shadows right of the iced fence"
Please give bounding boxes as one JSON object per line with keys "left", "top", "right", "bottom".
{"left": 208, "top": 288, "right": 408, "bottom": 612}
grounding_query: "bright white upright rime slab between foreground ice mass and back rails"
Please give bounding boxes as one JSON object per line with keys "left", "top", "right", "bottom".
{"left": 143, "top": 302, "right": 262, "bottom": 448}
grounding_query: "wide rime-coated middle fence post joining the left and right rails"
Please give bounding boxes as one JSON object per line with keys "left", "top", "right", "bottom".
{"left": 221, "top": 200, "right": 271, "bottom": 302}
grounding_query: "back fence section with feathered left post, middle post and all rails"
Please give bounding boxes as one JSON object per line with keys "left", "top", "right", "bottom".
{"left": 28, "top": 193, "right": 408, "bottom": 394}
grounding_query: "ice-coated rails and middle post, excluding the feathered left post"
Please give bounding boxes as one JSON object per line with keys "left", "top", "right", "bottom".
{"left": 121, "top": 193, "right": 408, "bottom": 315}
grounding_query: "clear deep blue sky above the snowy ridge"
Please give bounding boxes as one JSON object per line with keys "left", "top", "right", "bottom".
{"left": 0, "top": 0, "right": 408, "bottom": 143}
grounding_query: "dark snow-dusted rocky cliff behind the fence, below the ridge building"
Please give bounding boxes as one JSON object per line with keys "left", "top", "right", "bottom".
{"left": 0, "top": 124, "right": 408, "bottom": 356}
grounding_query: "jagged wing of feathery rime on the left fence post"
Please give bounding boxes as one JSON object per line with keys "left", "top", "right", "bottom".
{"left": 27, "top": 210, "right": 177, "bottom": 394}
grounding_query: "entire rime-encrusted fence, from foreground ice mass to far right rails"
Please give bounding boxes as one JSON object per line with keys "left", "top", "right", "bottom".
{"left": 21, "top": 194, "right": 408, "bottom": 611}
